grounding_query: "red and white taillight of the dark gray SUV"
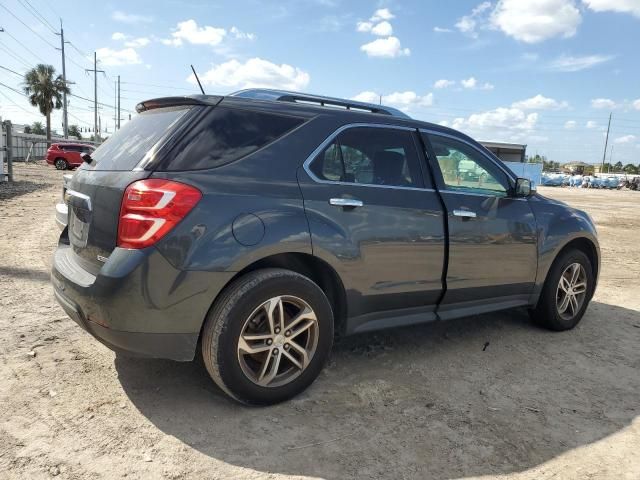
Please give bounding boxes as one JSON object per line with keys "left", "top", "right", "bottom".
{"left": 118, "top": 178, "right": 202, "bottom": 248}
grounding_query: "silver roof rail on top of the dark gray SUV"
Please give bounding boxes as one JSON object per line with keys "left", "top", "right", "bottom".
{"left": 230, "top": 88, "right": 410, "bottom": 118}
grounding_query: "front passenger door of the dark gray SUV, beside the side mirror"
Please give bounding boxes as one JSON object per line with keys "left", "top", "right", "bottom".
{"left": 422, "top": 131, "right": 537, "bottom": 317}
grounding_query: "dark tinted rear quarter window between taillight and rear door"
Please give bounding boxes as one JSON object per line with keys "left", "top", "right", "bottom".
{"left": 164, "top": 107, "right": 304, "bottom": 170}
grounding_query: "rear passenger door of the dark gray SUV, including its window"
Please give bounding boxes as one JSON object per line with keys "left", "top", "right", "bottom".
{"left": 298, "top": 125, "right": 445, "bottom": 331}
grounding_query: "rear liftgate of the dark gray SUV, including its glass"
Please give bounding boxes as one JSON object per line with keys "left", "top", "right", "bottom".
{"left": 67, "top": 105, "right": 198, "bottom": 275}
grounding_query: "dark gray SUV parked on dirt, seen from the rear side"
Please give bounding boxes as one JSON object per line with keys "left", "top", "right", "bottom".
{"left": 52, "top": 90, "right": 600, "bottom": 404}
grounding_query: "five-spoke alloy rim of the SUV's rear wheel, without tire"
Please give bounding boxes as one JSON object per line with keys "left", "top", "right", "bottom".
{"left": 238, "top": 295, "right": 319, "bottom": 387}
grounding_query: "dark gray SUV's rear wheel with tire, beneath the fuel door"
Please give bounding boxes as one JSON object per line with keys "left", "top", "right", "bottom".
{"left": 201, "top": 269, "right": 333, "bottom": 405}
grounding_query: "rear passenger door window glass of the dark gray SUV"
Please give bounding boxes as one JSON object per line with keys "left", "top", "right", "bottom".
{"left": 311, "top": 127, "right": 423, "bottom": 187}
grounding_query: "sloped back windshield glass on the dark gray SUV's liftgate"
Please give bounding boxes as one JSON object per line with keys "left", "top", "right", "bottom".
{"left": 83, "top": 106, "right": 191, "bottom": 170}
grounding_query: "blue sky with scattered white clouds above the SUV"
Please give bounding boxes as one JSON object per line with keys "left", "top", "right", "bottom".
{"left": 0, "top": 0, "right": 640, "bottom": 164}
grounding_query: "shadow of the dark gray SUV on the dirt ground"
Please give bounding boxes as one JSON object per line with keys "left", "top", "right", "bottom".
{"left": 115, "top": 302, "right": 640, "bottom": 479}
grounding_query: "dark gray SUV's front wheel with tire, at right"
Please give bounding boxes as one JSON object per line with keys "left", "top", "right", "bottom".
{"left": 530, "top": 249, "right": 595, "bottom": 332}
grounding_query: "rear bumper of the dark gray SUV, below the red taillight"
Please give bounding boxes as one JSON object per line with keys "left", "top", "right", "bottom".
{"left": 51, "top": 240, "right": 233, "bottom": 361}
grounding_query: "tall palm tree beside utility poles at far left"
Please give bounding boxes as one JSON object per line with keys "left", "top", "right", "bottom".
{"left": 24, "top": 63, "right": 71, "bottom": 140}
